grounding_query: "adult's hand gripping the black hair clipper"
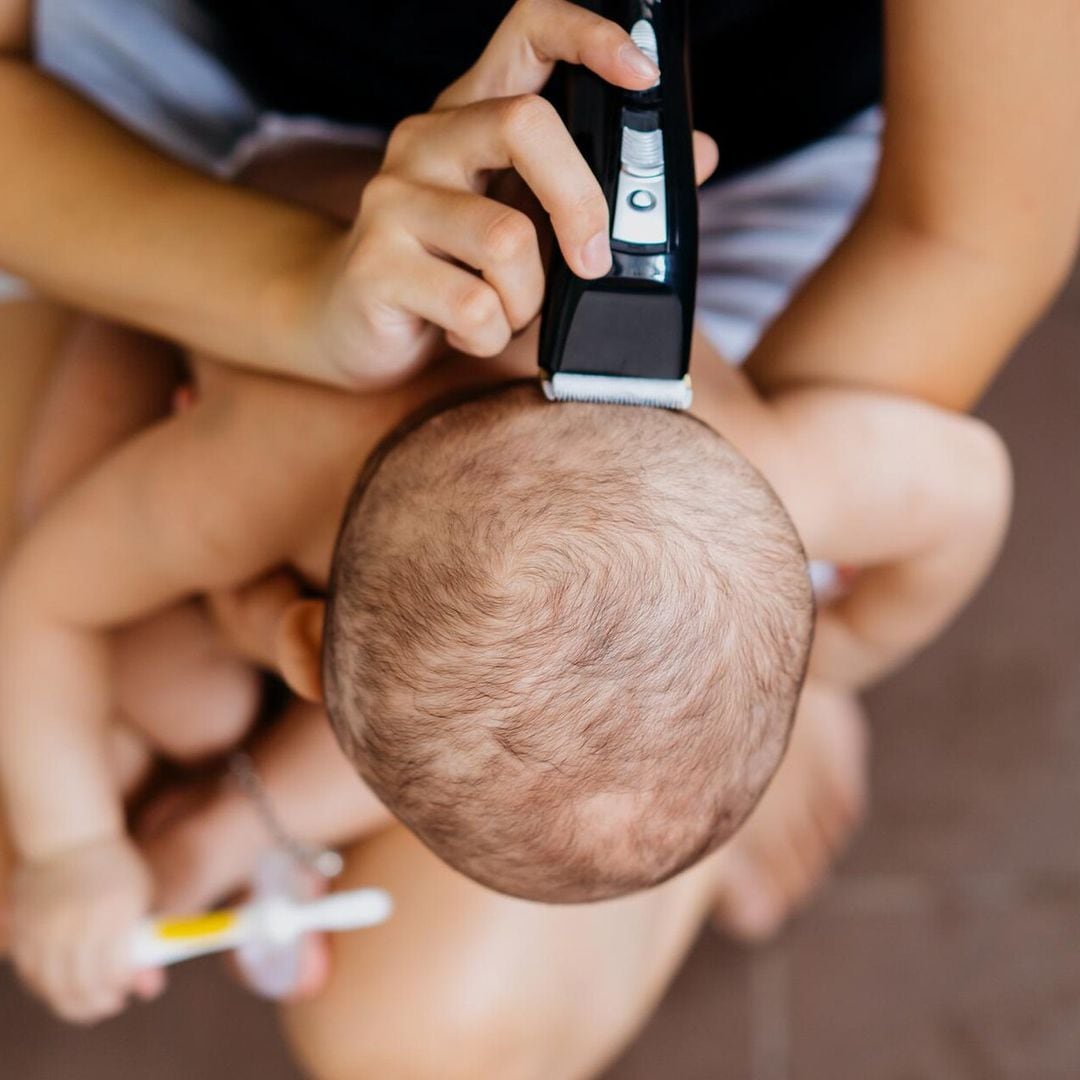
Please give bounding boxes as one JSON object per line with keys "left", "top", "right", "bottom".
{"left": 304, "top": 0, "right": 716, "bottom": 378}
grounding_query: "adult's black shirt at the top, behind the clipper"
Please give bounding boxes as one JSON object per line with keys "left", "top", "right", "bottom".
{"left": 200, "top": 0, "right": 881, "bottom": 176}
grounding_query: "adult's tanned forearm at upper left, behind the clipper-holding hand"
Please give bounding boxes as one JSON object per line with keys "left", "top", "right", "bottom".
{"left": 0, "top": 57, "right": 339, "bottom": 380}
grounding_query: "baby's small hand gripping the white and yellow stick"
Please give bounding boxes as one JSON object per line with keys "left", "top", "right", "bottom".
{"left": 12, "top": 837, "right": 163, "bottom": 1024}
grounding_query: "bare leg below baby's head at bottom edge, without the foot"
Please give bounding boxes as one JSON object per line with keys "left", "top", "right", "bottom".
{"left": 284, "top": 827, "right": 712, "bottom": 1080}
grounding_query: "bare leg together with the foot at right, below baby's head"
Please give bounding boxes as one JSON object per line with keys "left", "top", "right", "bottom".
{"left": 284, "top": 685, "right": 865, "bottom": 1080}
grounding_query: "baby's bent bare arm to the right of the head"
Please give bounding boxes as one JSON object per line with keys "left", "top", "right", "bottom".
{"left": 774, "top": 389, "right": 1011, "bottom": 688}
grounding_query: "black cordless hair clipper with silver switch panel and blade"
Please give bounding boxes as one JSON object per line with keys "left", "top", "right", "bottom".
{"left": 540, "top": 0, "right": 698, "bottom": 409}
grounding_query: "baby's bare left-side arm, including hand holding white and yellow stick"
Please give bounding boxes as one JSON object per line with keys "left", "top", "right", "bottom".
{"left": 0, "top": 399, "right": 295, "bottom": 1020}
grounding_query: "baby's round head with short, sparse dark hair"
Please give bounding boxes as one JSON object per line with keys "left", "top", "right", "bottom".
{"left": 323, "top": 383, "right": 813, "bottom": 902}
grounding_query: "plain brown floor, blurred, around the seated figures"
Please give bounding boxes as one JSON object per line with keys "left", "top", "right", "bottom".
{"left": 0, "top": 265, "right": 1080, "bottom": 1080}
